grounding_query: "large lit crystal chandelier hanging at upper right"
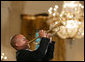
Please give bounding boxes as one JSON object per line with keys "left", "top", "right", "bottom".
{"left": 48, "top": 1, "right": 84, "bottom": 39}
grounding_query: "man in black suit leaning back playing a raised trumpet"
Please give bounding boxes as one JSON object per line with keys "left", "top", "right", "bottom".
{"left": 10, "top": 30, "right": 55, "bottom": 61}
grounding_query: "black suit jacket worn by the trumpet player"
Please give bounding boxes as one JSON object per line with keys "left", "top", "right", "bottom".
{"left": 16, "top": 38, "right": 55, "bottom": 61}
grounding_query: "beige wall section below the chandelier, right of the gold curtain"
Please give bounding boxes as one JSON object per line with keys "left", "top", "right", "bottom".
{"left": 65, "top": 38, "right": 84, "bottom": 61}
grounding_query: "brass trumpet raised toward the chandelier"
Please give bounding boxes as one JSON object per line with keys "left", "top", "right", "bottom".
{"left": 28, "top": 22, "right": 63, "bottom": 44}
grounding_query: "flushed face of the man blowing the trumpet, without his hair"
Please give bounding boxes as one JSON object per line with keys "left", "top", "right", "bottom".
{"left": 16, "top": 34, "right": 28, "bottom": 46}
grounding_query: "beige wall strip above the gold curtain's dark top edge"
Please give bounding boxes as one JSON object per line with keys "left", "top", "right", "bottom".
{"left": 23, "top": 1, "right": 63, "bottom": 15}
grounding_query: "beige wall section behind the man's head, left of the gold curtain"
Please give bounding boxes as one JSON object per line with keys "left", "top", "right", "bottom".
{"left": 1, "top": 1, "right": 23, "bottom": 61}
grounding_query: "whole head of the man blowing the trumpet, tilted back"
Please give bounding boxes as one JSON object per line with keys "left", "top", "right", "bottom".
{"left": 10, "top": 34, "right": 28, "bottom": 50}
